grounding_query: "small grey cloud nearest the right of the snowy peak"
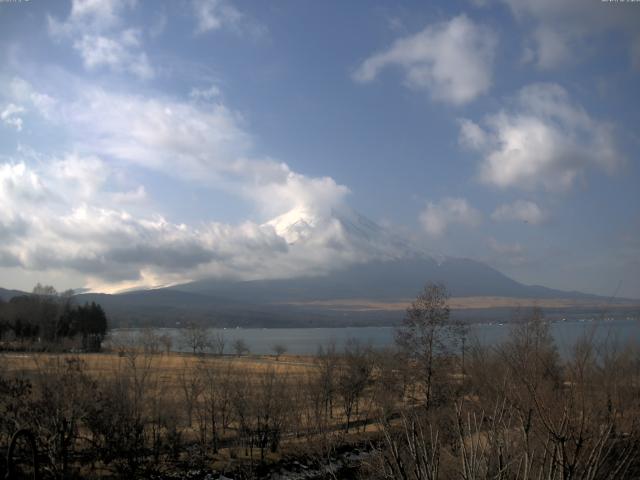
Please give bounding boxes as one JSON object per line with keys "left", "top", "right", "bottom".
{"left": 420, "top": 197, "right": 482, "bottom": 237}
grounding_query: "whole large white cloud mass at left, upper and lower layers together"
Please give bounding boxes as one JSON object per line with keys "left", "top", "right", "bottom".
{"left": 0, "top": 76, "right": 398, "bottom": 291}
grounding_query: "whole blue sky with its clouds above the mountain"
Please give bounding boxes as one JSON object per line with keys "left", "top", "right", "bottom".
{"left": 0, "top": 0, "right": 640, "bottom": 298}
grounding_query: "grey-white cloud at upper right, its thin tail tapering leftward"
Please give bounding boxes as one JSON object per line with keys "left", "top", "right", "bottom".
{"left": 353, "top": 15, "right": 497, "bottom": 105}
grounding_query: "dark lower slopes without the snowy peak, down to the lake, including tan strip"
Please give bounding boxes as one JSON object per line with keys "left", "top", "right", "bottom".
{"left": 65, "top": 256, "right": 638, "bottom": 327}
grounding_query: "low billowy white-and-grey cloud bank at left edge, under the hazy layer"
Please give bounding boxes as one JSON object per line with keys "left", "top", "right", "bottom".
{"left": 0, "top": 163, "right": 278, "bottom": 288}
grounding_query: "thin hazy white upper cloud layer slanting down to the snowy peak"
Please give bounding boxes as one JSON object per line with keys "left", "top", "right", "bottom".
{"left": 22, "top": 83, "right": 349, "bottom": 221}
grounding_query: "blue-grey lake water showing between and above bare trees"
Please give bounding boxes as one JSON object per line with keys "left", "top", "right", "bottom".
{"left": 111, "top": 318, "right": 640, "bottom": 357}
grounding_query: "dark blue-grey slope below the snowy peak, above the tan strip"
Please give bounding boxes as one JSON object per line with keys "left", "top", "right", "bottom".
{"left": 170, "top": 257, "right": 598, "bottom": 303}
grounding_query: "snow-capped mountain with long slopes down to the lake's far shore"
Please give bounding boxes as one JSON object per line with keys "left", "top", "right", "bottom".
{"left": 67, "top": 207, "right": 637, "bottom": 327}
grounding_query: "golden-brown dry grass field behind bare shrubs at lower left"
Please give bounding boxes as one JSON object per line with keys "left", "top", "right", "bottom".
{"left": 0, "top": 349, "right": 376, "bottom": 478}
